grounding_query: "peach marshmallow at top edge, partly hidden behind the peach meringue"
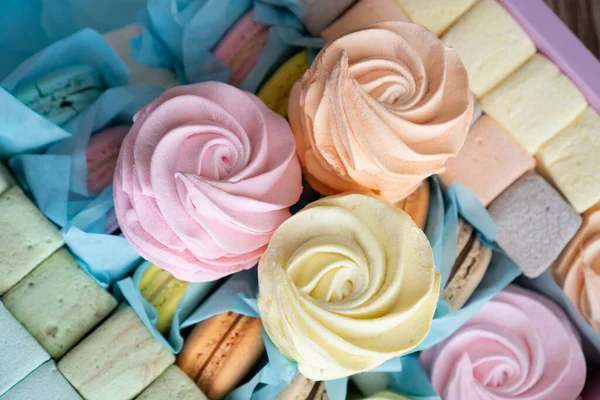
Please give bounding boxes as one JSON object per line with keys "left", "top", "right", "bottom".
{"left": 321, "top": 0, "right": 411, "bottom": 42}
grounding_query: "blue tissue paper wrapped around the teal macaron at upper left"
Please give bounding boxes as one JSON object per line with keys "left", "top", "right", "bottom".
{"left": 0, "top": 29, "right": 127, "bottom": 158}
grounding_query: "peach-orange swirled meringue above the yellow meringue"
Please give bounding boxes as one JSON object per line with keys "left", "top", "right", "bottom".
{"left": 288, "top": 21, "right": 473, "bottom": 203}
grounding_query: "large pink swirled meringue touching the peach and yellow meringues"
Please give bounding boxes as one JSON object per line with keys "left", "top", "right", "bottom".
{"left": 114, "top": 82, "right": 302, "bottom": 281}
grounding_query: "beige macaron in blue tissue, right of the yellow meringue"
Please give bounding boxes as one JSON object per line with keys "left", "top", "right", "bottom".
{"left": 442, "top": 218, "right": 492, "bottom": 311}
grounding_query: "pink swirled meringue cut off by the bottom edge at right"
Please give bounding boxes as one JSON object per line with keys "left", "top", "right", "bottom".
{"left": 421, "top": 285, "right": 586, "bottom": 400}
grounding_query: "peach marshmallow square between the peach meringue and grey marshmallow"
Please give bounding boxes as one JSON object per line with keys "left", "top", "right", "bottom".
{"left": 440, "top": 115, "right": 535, "bottom": 206}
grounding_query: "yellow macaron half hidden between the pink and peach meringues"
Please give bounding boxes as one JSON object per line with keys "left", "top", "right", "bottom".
{"left": 258, "top": 51, "right": 308, "bottom": 117}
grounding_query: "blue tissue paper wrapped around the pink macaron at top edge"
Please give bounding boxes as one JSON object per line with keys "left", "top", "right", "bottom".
{"left": 131, "top": 0, "right": 324, "bottom": 92}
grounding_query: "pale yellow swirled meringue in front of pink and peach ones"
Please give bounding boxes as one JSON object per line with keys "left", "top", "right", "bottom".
{"left": 258, "top": 194, "right": 440, "bottom": 380}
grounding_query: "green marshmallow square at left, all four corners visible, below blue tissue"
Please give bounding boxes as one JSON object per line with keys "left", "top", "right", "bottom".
{"left": 3, "top": 249, "right": 117, "bottom": 359}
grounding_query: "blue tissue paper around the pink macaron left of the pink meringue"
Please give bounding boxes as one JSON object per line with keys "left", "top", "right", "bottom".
{"left": 10, "top": 86, "right": 162, "bottom": 288}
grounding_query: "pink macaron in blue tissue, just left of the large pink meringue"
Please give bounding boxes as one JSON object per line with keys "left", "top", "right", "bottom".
{"left": 85, "top": 125, "right": 129, "bottom": 193}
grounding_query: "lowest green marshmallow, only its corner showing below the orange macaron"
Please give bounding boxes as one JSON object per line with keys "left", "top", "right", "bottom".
{"left": 136, "top": 365, "right": 207, "bottom": 400}
